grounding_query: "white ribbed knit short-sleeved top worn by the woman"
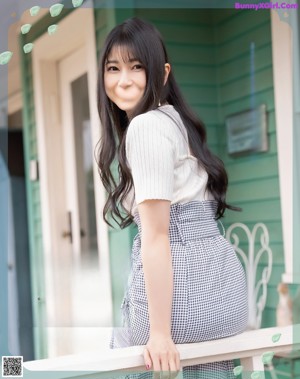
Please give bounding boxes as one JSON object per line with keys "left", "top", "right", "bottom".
{"left": 123, "top": 104, "right": 213, "bottom": 215}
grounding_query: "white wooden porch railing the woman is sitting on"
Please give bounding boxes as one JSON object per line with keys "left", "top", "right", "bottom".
{"left": 24, "top": 324, "right": 300, "bottom": 379}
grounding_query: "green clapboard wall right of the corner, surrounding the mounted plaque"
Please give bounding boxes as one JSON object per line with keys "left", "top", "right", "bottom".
{"left": 213, "top": 10, "right": 284, "bottom": 327}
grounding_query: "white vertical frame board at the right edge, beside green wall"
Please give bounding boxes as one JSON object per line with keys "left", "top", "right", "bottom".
{"left": 271, "top": 10, "right": 300, "bottom": 283}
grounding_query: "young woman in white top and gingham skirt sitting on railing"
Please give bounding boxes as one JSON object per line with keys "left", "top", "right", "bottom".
{"left": 98, "top": 18, "right": 248, "bottom": 379}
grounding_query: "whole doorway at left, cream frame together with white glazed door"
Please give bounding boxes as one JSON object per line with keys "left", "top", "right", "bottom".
{"left": 33, "top": 8, "right": 112, "bottom": 357}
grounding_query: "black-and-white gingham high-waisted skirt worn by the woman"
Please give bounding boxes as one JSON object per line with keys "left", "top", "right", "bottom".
{"left": 110, "top": 200, "right": 248, "bottom": 379}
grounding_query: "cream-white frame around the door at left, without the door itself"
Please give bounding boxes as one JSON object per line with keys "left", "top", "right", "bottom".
{"left": 32, "top": 1, "right": 112, "bottom": 357}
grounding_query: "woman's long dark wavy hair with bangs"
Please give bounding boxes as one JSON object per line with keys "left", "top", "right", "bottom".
{"left": 97, "top": 17, "right": 239, "bottom": 229}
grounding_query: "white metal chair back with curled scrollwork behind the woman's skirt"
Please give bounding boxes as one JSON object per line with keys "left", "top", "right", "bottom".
{"left": 226, "top": 222, "right": 273, "bottom": 329}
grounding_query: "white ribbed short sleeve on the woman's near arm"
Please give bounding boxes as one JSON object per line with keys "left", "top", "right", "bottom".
{"left": 126, "top": 112, "right": 176, "bottom": 204}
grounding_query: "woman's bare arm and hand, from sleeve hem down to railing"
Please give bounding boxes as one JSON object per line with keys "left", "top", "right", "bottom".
{"left": 138, "top": 200, "right": 180, "bottom": 374}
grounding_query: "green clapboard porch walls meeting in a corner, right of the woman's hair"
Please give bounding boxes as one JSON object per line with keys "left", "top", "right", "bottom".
{"left": 126, "top": 8, "right": 284, "bottom": 326}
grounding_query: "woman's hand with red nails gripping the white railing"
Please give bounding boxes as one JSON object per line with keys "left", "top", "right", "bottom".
{"left": 144, "top": 334, "right": 180, "bottom": 379}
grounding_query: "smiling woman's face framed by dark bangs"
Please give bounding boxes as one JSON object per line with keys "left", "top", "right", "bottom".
{"left": 104, "top": 47, "right": 146, "bottom": 117}
